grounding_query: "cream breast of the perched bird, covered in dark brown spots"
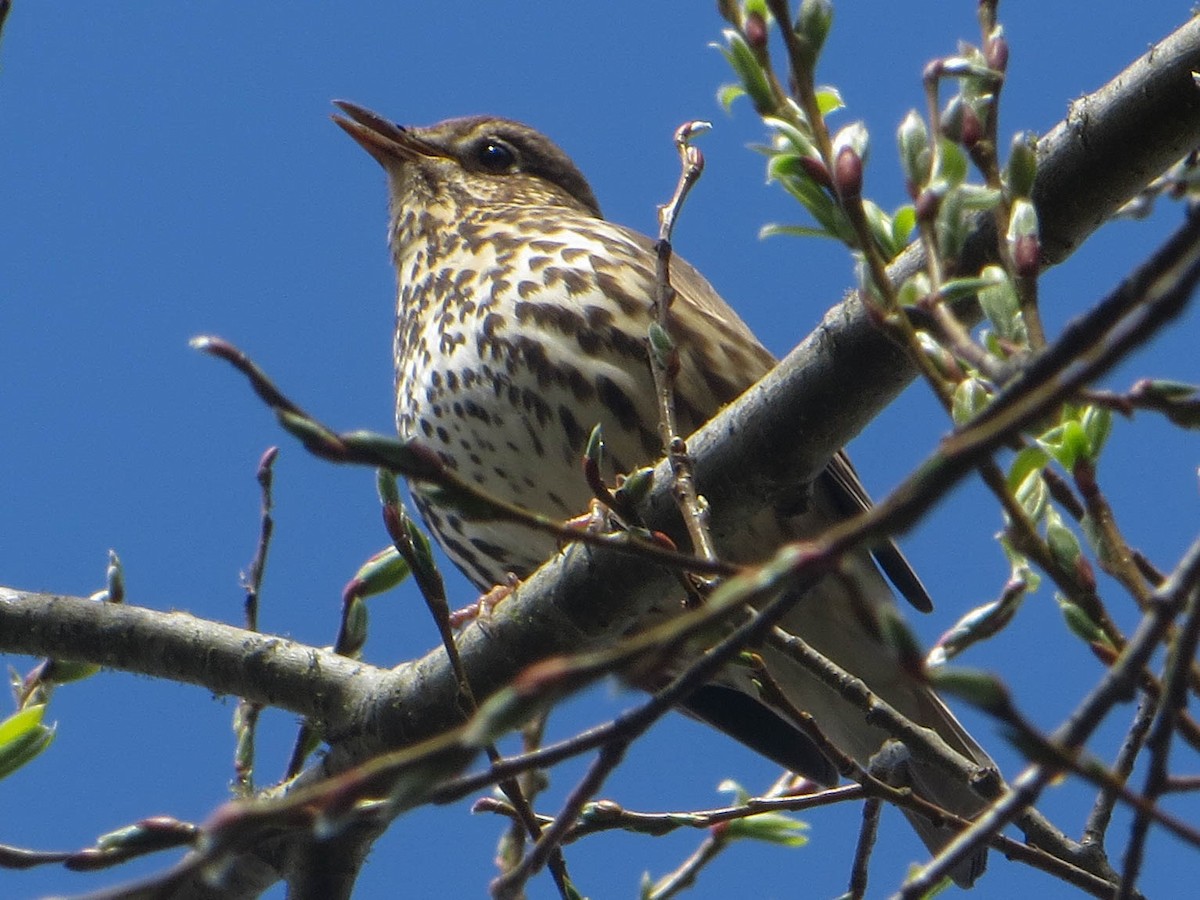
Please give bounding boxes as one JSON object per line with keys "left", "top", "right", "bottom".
{"left": 395, "top": 208, "right": 676, "bottom": 584}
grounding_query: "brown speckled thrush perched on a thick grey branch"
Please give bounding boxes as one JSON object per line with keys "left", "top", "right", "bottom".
{"left": 334, "top": 101, "right": 994, "bottom": 886}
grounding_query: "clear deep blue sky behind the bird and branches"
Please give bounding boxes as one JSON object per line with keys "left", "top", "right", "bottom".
{"left": 0, "top": 0, "right": 1200, "bottom": 898}
